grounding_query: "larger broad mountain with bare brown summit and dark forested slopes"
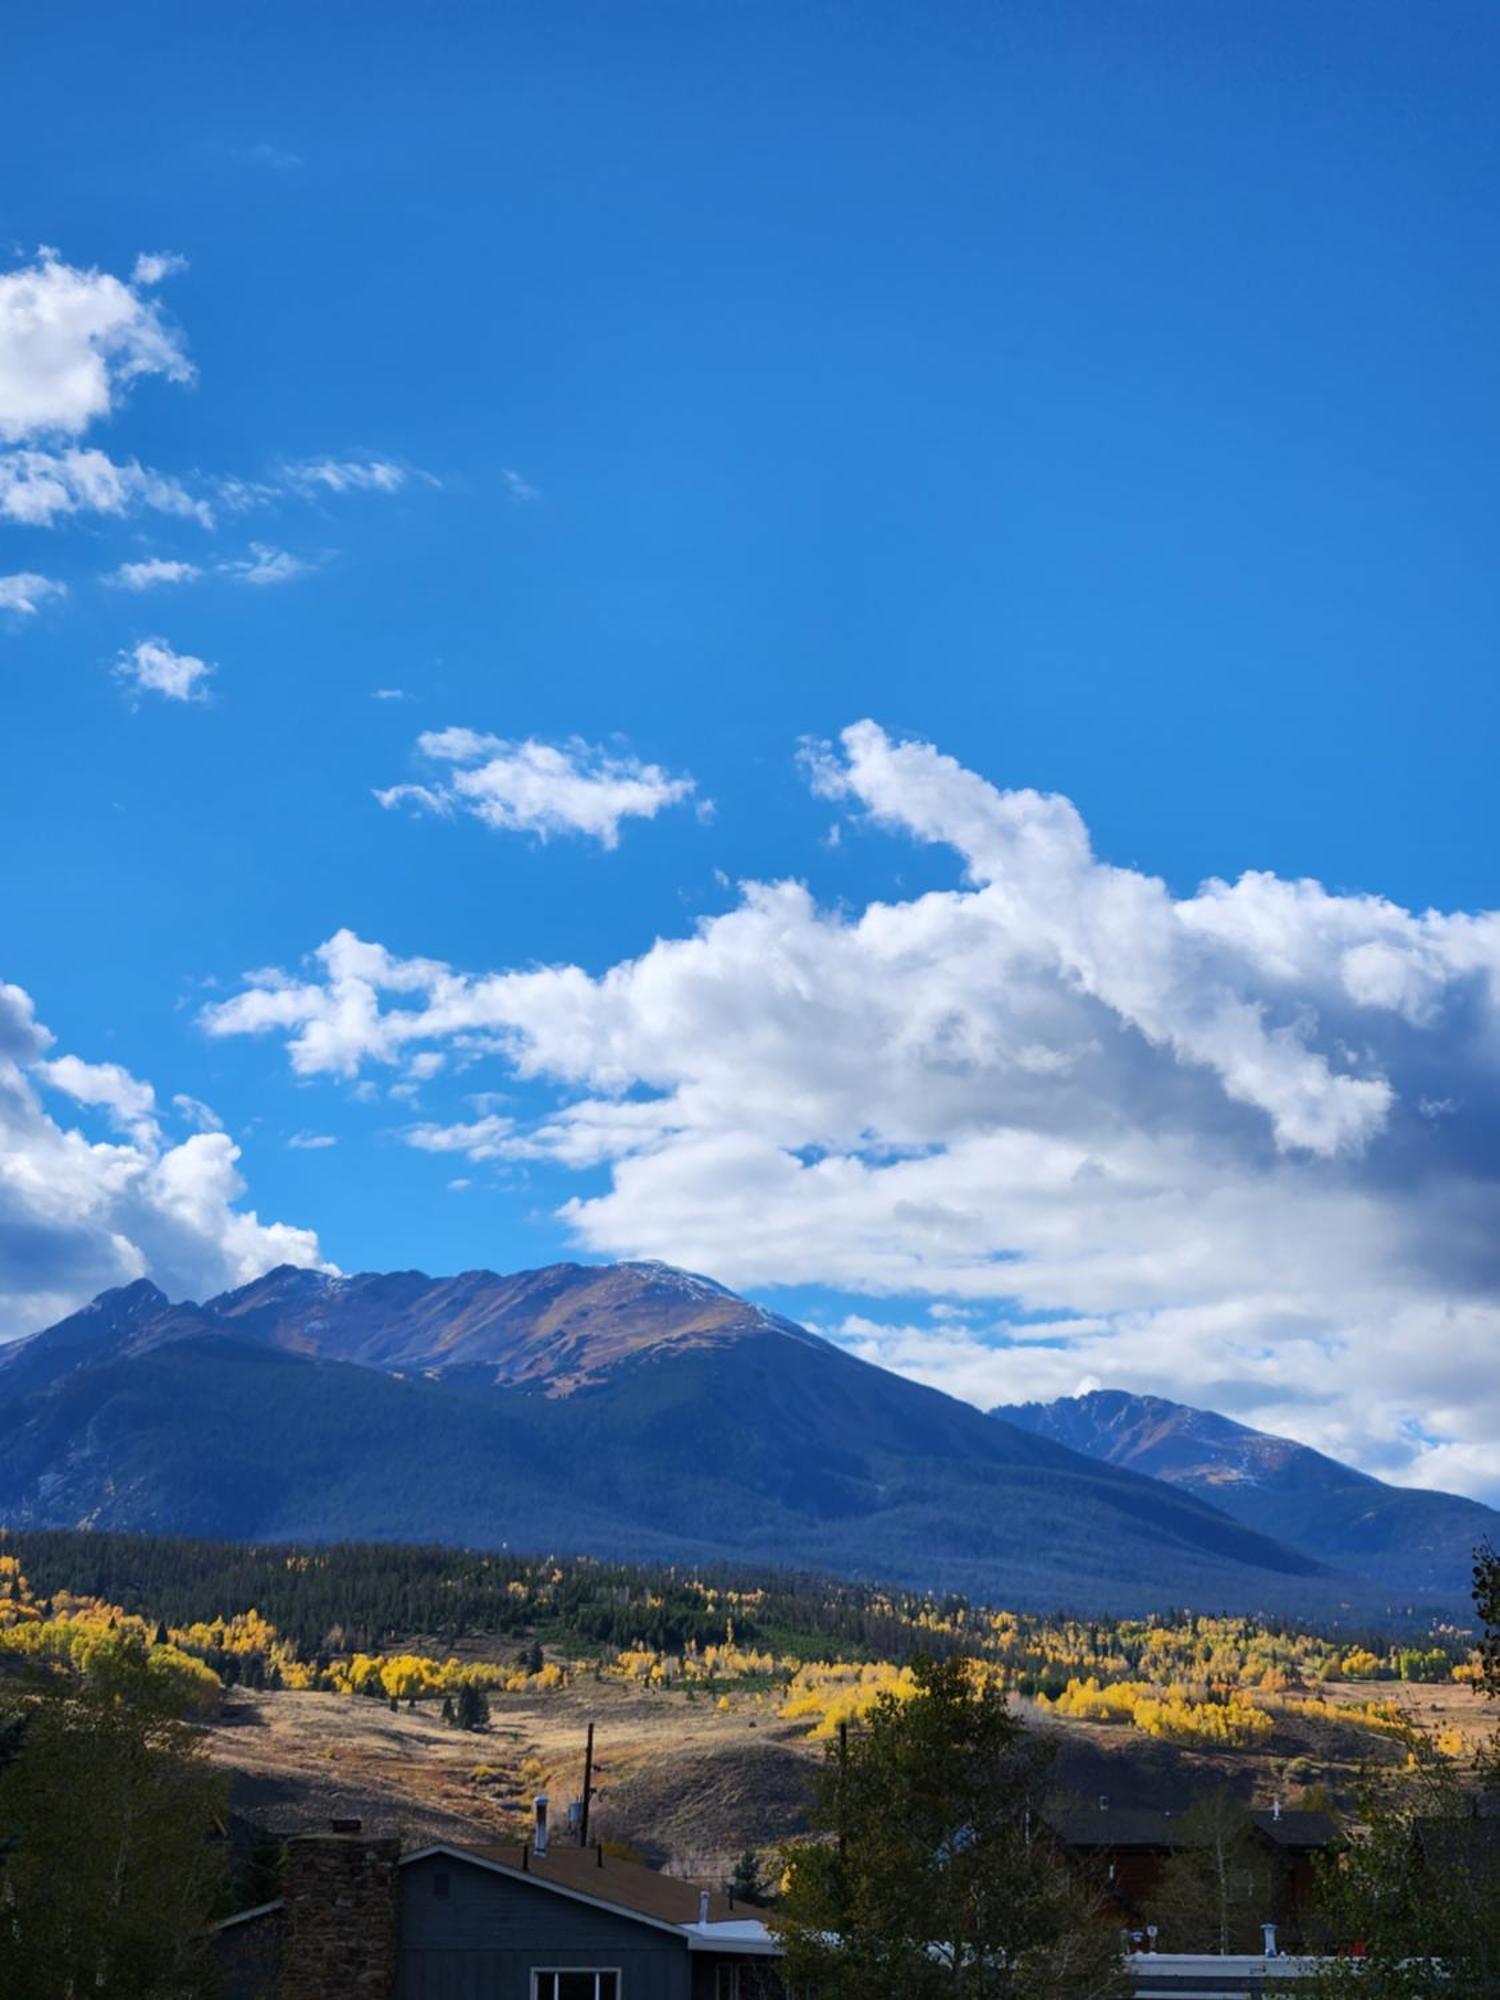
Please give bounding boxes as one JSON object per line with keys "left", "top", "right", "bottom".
{"left": 0, "top": 1264, "right": 1374, "bottom": 1614}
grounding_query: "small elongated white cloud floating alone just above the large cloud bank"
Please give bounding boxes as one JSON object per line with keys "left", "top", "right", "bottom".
{"left": 376, "top": 728, "right": 694, "bottom": 848}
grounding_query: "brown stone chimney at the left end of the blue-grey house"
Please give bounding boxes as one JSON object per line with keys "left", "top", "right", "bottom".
{"left": 278, "top": 1820, "right": 400, "bottom": 2000}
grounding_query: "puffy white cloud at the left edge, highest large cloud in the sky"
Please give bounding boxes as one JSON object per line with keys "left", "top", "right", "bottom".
{"left": 0, "top": 250, "right": 192, "bottom": 444}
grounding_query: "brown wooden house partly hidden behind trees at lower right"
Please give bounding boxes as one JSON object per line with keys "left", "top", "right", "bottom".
{"left": 1046, "top": 1796, "right": 1340, "bottom": 1944}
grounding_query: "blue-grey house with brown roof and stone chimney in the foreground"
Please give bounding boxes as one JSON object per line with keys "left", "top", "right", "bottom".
{"left": 216, "top": 1822, "right": 780, "bottom": 2000}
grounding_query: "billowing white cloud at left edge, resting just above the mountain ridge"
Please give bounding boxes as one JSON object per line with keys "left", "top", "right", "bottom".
{"left": 0, "top": 986, "right": 322, "bottom": 1338}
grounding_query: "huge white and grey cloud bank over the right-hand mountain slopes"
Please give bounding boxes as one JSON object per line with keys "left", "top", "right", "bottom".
{"left": 204, "top": 722, "right": 1500, "bottom": 1486}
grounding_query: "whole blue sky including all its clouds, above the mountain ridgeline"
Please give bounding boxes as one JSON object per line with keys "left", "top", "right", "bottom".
{"left": 0, "top": 4, "right": 1500, "bottom": 1492}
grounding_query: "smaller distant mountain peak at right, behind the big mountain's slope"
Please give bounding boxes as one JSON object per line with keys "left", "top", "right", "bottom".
{"left": 992, "top": 1390, "right": 1500, "bottom": 1604}
